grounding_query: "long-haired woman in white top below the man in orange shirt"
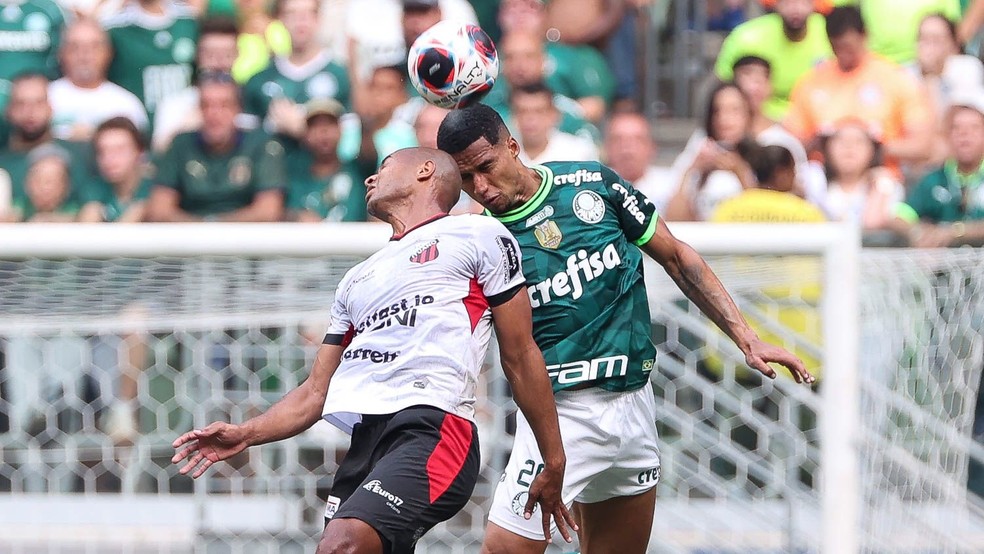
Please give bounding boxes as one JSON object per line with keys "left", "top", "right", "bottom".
{"left": 822, "top": 119, "right": 905, "bottom": 231}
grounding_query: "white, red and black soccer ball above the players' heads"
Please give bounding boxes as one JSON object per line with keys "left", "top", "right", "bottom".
{"left": 407, "top": 21, "right": 499, "bottom": 110}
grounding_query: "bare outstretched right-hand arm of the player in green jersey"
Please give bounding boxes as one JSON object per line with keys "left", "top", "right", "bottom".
{"left": 642, "top": 220, "right": 816, "bottom": 383}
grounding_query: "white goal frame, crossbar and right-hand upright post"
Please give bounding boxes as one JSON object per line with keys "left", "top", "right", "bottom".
{"left": 0, "top": 223, "right": 862, "bottom": 554}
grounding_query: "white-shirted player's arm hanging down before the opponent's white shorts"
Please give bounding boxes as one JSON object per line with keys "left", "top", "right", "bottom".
{"left": 492, "top": 290, "right": 577, "bottom": 542}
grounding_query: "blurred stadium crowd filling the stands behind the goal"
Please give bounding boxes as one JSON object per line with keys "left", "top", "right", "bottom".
{"left": 0, "top": 0, "right": 984, "bottom": 491}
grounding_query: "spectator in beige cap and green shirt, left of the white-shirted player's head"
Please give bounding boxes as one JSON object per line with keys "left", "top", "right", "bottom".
{"left": 287, "top": 98, "right": 375, "bottom": 222}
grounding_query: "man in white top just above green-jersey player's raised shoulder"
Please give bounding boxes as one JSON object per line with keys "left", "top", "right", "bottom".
{"left": 604, "top": 112, "right": 675, "bottom": 214}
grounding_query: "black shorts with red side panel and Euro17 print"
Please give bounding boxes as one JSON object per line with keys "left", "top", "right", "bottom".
{"left": 325, "top": 406, "right": 480, "bottom": 554}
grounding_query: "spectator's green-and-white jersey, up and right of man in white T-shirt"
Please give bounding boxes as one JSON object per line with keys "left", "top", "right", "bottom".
{"left": 105, "top": 2, "right": 198, "bottom": 121}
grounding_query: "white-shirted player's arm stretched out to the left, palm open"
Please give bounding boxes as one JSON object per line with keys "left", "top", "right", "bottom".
{"left": 171, "top": 344, "right": 343, "bottom": 478}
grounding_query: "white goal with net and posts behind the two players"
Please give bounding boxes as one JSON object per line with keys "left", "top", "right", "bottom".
{"left": 0, "top": 224, "right": 984, "bottom": 553}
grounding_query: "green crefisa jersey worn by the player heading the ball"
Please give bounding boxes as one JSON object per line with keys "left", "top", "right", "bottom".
{"left": 495, "top": 162, "right": 657, "bottom": 391}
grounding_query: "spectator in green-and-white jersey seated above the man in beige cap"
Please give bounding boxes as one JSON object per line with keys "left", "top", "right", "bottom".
{"left": 243, "top": 0, "right": 351, "bottom": 139}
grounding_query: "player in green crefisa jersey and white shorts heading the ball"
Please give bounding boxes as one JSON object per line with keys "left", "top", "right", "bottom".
{"left": 437, "top": 104, "right": 814, "bottom": 554}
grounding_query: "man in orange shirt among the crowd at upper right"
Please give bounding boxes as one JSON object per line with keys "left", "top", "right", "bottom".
{"left": 784, "top": 6, "right": 934, "bottom": 170}
